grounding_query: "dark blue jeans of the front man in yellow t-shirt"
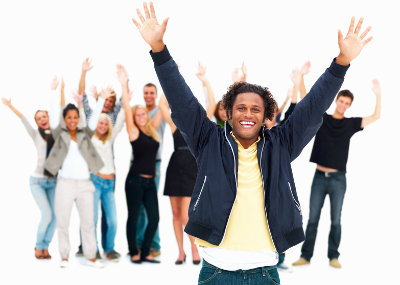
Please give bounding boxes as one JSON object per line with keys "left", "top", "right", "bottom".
{"left": 198, "top": 259, "right": 280, "bottom": 285}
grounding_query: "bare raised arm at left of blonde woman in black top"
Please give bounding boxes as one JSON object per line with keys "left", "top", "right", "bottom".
{"left": 117, "top": 65, "right": 139, "bottom": 141}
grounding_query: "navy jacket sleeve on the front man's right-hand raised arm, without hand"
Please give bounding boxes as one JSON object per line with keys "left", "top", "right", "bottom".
{"left": 277, "top": 60, "right": 349, "bottom": 161}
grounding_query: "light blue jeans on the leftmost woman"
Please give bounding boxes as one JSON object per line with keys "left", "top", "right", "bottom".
{"left": 29, "top": 176, "right": 57, "bottom": 250}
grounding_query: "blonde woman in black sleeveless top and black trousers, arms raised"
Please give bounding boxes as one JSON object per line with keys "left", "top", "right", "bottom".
{"left": 118, "top": 65, "right": 162, "bottom": 263}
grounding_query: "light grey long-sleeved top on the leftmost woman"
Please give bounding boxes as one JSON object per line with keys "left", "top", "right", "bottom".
{"left": 21, "top": 116, "right": 50, "bottom": 178}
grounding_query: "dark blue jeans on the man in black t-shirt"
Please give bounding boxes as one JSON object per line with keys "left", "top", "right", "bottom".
{"left": 301, "top": 170, "right": 346, "bottom": 261}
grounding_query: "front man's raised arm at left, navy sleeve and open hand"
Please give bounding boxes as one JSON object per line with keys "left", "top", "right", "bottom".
{"left": 132, "top": 2, "right": 217, "bottom": 157}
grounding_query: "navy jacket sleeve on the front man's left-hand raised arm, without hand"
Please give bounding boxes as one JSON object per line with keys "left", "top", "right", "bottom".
{"left": 150, "top": 47, "right": 216, "bottom": 158}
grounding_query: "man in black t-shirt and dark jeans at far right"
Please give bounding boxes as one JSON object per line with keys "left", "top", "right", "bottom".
{"left": 293, "top": 79, "right": 381, "bottom": 268}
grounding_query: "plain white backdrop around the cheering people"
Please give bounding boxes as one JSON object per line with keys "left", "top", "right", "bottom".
{"left": 0, "top": 0, "right": 400, "bottom": 284}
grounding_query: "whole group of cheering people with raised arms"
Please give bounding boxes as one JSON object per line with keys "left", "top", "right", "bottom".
{"left": 2, "top": 3, "right": 381, "bottom": 284}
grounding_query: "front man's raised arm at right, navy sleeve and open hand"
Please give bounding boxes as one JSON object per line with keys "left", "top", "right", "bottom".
{"left": 279, "top": 17, "right": 372, "bottom": 160}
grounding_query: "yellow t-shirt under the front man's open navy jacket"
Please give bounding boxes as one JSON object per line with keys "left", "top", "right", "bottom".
{"left": 196, "top": 132, "right": 275, "bottom": 251}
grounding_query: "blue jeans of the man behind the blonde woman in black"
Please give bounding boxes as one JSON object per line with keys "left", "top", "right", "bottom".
{"left": 136, "top": 160, "right": 161, "bottom": 251}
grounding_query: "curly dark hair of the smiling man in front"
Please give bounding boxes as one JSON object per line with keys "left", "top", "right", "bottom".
{"left": 222, "top": 81, "right": 277, "bottom": 120}
